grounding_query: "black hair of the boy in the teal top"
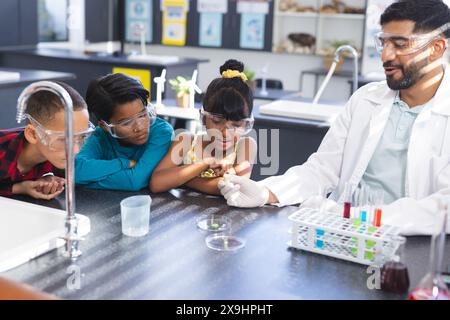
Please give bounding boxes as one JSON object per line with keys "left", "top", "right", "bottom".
{"left": 86, "top": 73, "right": 149, "bottom": 121}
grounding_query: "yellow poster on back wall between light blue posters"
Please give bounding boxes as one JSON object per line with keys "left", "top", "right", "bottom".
{"left": 162, "top": 0, "right": 188, "bottom": 46}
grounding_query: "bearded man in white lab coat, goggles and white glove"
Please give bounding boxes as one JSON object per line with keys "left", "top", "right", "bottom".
{"left": 219, "top": 0, "right": 450, "bottom": 235}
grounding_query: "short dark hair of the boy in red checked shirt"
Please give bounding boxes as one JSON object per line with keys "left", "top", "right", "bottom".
{"left": 25, "top": 81, "right": 87, "bottom": 123}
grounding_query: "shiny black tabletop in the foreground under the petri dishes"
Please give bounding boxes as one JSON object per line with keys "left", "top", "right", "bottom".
{"left": 3, "top": 188, "right": 449, "bottom": 299}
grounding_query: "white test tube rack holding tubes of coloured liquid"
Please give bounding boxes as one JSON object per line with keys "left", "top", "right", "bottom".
{"left": 288, "top": 208, "right": 400, "bottom": 265}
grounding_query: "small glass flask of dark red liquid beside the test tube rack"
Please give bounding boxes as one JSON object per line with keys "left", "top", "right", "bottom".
{"left": 381, "top": 236, "right": 409, "bottom": 293}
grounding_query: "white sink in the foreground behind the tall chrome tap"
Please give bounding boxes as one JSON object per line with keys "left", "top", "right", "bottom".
{"left": 0, "top": 197, "right": 90, "bottom": 272}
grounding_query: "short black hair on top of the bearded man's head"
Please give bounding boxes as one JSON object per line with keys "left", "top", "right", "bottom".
{"left": 380, "top": 0, "right": 450, "bottom": 38}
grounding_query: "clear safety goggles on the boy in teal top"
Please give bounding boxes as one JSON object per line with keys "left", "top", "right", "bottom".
{"left": 103, "top": 105, "right": 156, "bottom": 139}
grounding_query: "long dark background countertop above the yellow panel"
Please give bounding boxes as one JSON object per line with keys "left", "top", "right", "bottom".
{"left": 0, "top": 48, "right": 209, "bottom": 67}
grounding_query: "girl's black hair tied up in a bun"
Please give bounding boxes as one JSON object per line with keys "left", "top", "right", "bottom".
{"left": 203, "top": 59, "right": 253, "bottom": 121}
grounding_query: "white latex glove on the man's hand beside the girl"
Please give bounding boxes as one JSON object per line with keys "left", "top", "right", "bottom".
{"left": 218, "top": 174, "right": 270, "bottom": 208}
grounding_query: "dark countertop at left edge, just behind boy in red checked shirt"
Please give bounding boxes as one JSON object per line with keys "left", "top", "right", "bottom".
{"left": 0, "top": 68, "right": 75, "bottom": 89}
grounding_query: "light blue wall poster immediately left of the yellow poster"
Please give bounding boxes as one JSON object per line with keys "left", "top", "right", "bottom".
{"left": 125, "top": 0, "right": 153, "bottom": 43}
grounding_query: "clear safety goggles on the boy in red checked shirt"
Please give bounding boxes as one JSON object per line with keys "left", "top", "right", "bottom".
{"left": 25, "top": 114, "right": 95, "bottom": 151}
